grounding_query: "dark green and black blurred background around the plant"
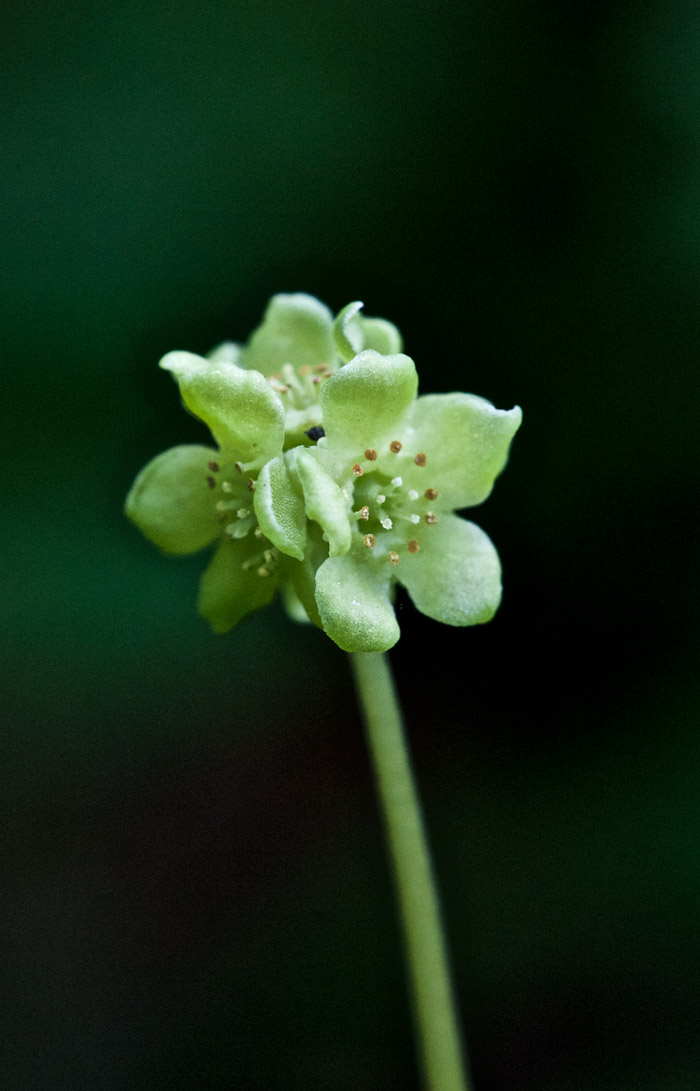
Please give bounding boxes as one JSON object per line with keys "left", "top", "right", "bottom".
{"left": 0, "top": 0, "right": 700, "bottom": 1091}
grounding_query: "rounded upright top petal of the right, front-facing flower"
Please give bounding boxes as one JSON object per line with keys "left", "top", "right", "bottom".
{"left": 321, "top": 349, "right": 418, "bottom": 458}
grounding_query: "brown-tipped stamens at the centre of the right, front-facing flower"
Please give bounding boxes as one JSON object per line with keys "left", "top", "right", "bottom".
{"left": 352, "top": 440, "right": 438, "bottom": 565}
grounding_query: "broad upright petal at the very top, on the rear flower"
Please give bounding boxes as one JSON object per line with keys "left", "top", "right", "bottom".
{"left": 244, "top": 292, "right": 335, "bottom": 375}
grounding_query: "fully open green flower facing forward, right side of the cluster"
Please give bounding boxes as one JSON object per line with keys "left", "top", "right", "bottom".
{"left": 260, "top": 344, "right": 521, "bottom": 651}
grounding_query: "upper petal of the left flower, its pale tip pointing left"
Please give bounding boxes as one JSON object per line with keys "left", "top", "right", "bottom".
{"left": 160, "top": 352, "right": 285, "bottom": 464}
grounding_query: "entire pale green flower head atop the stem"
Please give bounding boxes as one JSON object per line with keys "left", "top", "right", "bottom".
{"left": 126, "top": 295, "right": 521, "bottom": 651}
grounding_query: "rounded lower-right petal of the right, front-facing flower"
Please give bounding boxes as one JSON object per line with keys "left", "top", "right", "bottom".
{"left": 396, "top": 515, "right": 500, "bottom": 625}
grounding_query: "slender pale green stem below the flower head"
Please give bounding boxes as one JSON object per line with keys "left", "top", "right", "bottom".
{"left": 350, "top": 652, "right": 469, "bottom": 1091}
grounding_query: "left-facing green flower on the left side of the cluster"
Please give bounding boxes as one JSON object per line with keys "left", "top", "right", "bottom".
{"left": 125, "top": 340, "right": 289, "bottom": 633}
